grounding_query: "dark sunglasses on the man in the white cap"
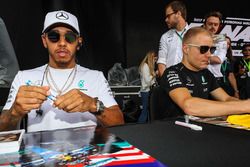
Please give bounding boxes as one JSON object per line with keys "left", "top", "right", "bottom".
{"left": 47, "top": 30, "right": 78, "bottom": 43}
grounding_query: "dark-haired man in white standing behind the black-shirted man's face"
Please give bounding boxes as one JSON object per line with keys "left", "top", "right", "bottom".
{"left": 203, "top": 11, "right": 227, "bottom": 85}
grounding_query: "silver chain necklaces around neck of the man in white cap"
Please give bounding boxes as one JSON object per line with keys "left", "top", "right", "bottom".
{"left": 46, "top": 65, "right": 77, "bottom": 95}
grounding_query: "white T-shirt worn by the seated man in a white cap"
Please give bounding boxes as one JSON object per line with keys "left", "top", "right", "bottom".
{"left": 3, "top": 65, "right": 117, "bottom": 132}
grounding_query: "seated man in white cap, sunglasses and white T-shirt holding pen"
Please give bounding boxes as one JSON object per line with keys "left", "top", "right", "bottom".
{"left": 0, "top": 11, "right": 124, "bottom": 132}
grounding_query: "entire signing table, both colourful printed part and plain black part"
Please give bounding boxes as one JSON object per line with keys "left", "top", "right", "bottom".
{"left": 0, "top": 119, "right": 250, "bottom": 167}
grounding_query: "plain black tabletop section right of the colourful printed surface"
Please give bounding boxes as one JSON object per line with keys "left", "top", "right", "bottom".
{"left": 109, "top": 120, "right": 250, "bottom": 167}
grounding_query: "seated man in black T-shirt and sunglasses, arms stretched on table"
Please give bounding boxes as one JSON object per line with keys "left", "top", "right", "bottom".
{"left": 160, "top": 27, "right": 250, "bottom": 117}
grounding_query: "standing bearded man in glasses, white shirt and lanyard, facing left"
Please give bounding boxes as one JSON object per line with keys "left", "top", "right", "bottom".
{"left": 157, "top": 0, "right": 188, "bottom": 76}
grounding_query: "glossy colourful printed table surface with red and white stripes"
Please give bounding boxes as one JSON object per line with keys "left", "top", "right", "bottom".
{"left": 0, "top": 126, "right": 166, "bottom": 167}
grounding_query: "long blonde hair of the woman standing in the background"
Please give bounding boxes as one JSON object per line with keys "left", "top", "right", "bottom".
{"left": 139, "top": 51, "right": 157, "bottom": 76}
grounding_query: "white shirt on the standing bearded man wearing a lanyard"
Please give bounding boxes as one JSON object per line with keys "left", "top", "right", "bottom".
{"left": 157, "top": 24, "right": 189, "bottom": 68}
